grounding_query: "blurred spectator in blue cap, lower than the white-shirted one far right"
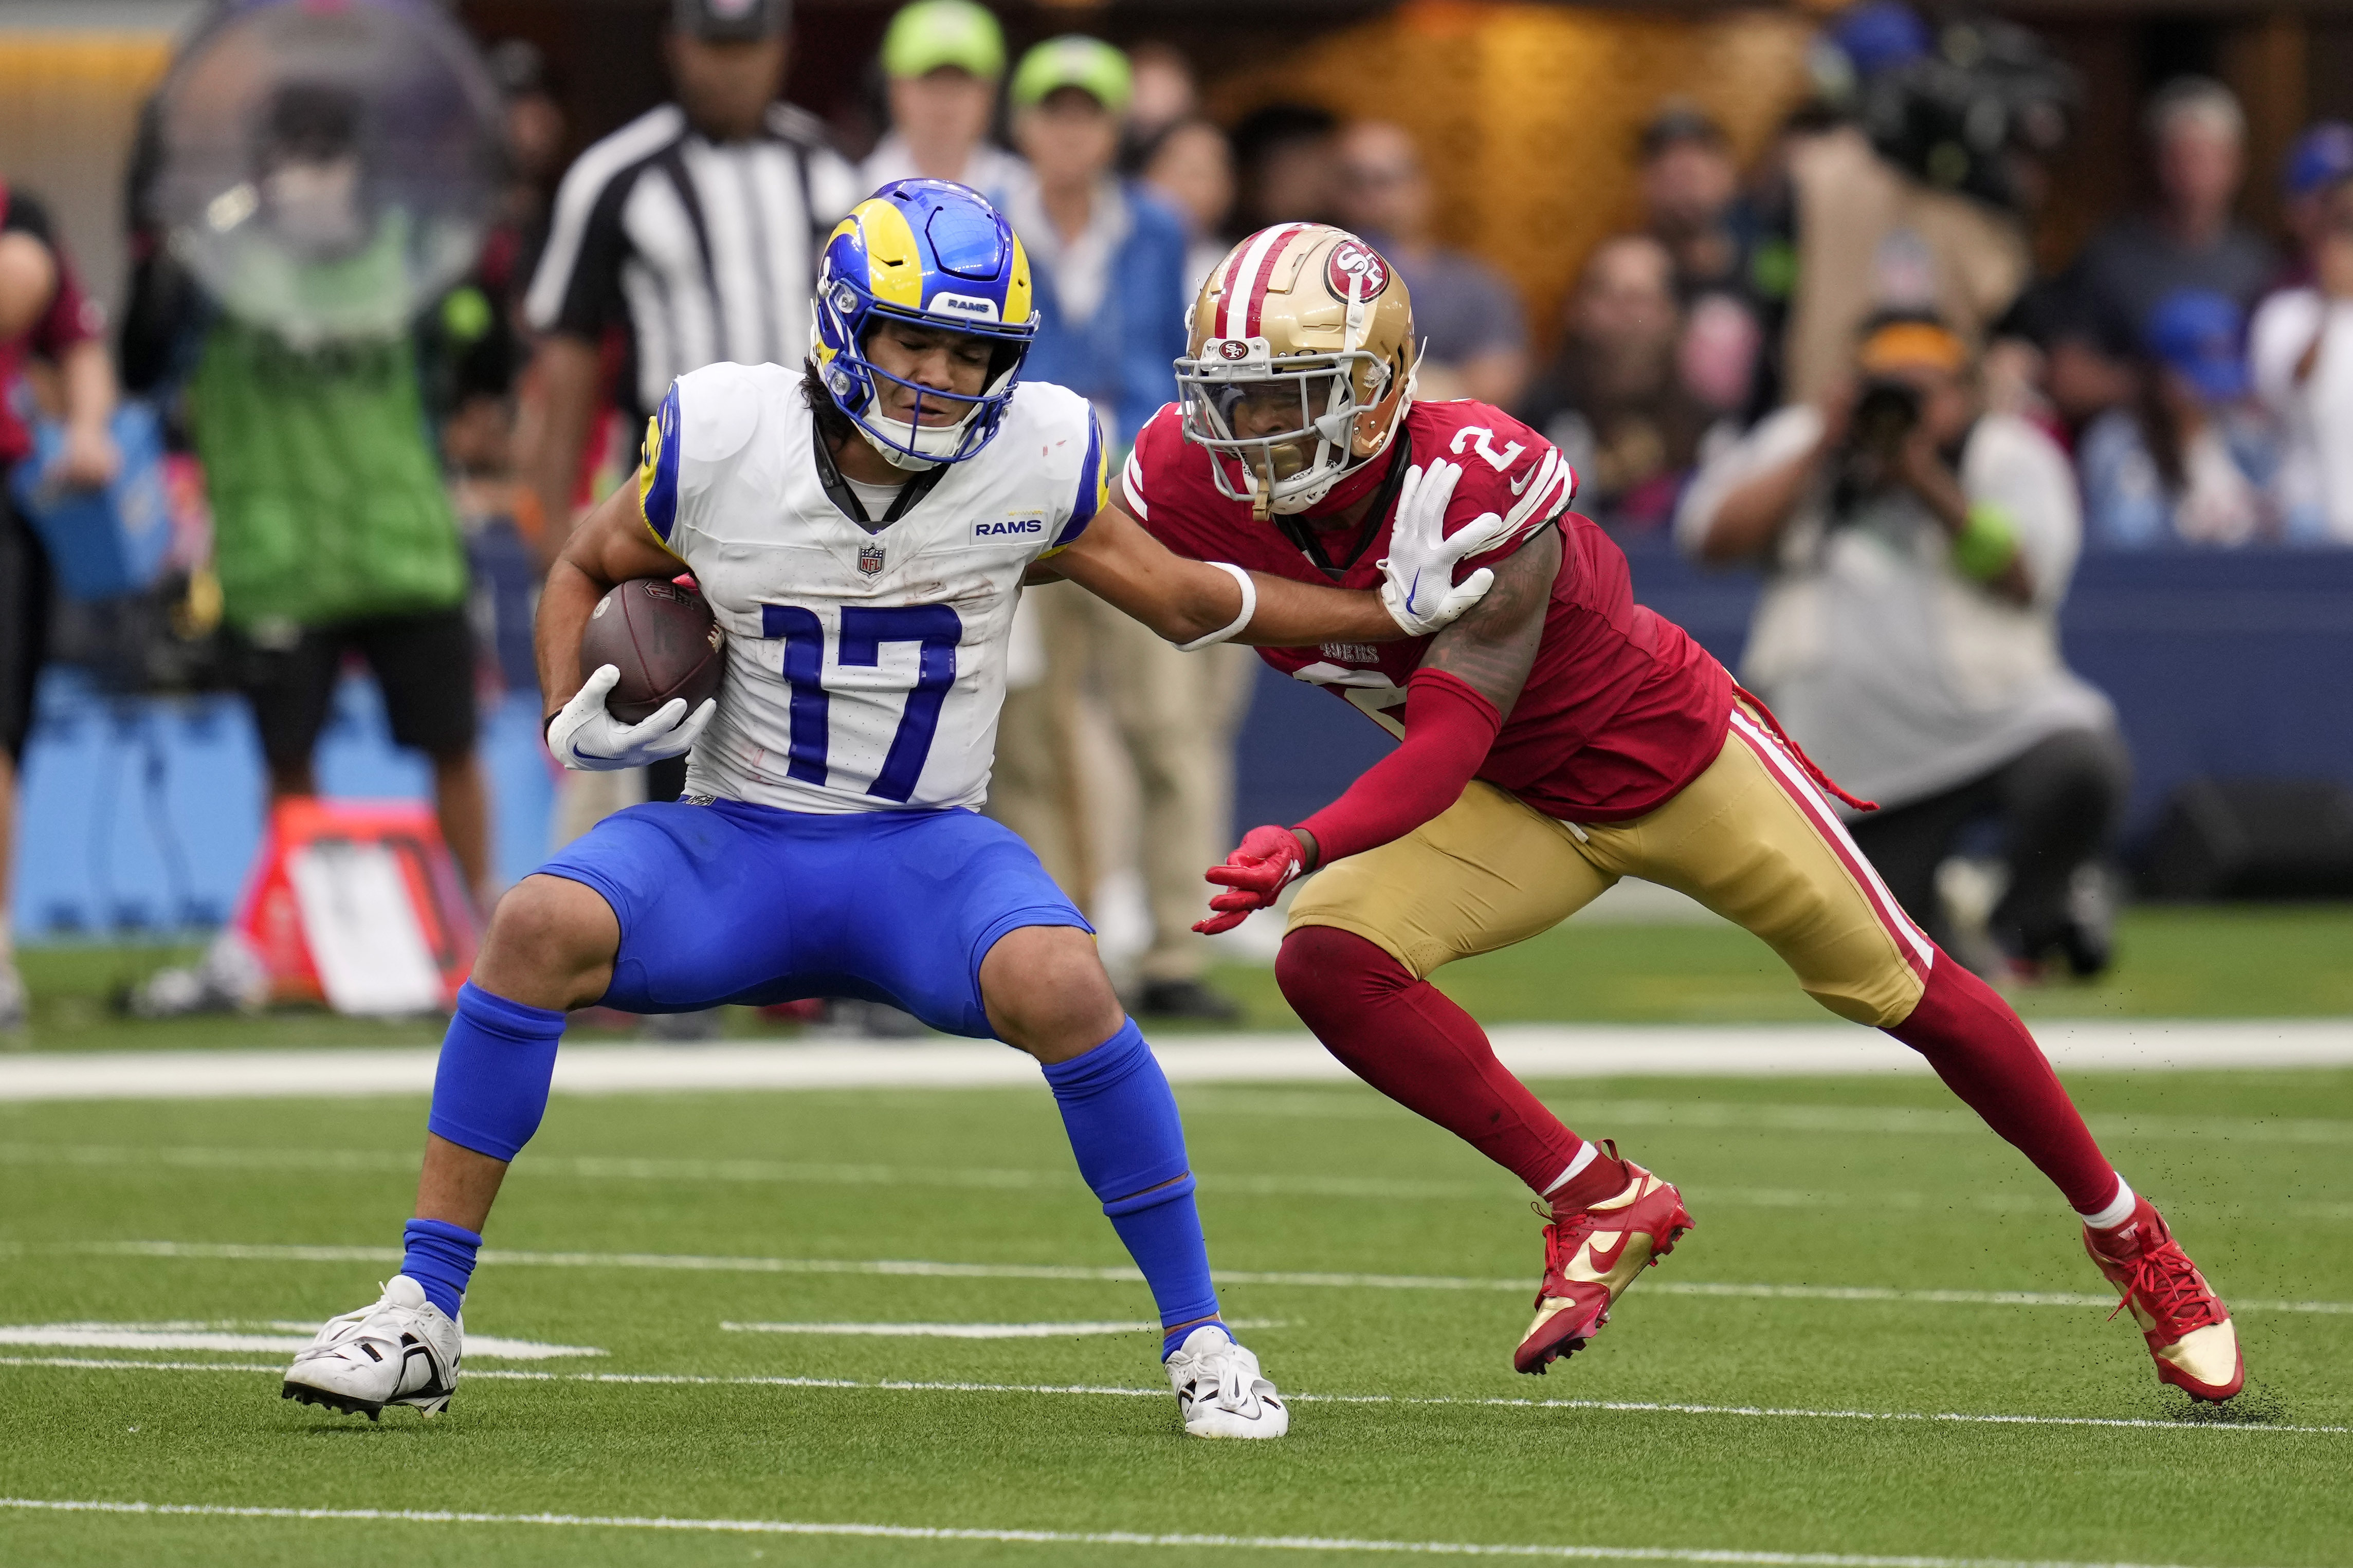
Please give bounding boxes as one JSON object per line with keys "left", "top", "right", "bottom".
{"left": 2075, "top": 289, "right": 2278, "bottom": 550}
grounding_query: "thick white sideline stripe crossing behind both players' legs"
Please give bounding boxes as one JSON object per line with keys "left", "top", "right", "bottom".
{"left": 13, "top": 1018, "right": 2353, "bottom": 1100}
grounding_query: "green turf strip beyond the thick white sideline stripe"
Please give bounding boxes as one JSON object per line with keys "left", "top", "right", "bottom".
{"left": 16, "top": 905, "right": 2353, "bottom": 1051}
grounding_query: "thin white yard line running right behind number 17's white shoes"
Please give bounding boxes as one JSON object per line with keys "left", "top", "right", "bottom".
{"left": 0, "top": 1356, "right": 2353, "bottom": 1436}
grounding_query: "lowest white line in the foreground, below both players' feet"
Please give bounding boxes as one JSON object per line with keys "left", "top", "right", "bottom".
{"left": 0, "top": 1498, "right": 2287, "bottom": 1568}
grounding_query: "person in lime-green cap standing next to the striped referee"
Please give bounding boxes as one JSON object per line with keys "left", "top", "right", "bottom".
{"left": 859, "top": 0, "right": 1021, "bottom": 200}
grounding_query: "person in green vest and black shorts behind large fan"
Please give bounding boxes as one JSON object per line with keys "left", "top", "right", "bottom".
{"left": 122, "top": 80, "right": 494, "bottom": 908}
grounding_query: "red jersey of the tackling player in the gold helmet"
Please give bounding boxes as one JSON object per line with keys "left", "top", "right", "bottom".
{"left": 1120, "top": 400, "right": 1732, "bottom": 823}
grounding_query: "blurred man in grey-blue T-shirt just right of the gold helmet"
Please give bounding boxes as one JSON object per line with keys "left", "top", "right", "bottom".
{"left": 1339, "top": 120, "right": 1529, "bottom": 409}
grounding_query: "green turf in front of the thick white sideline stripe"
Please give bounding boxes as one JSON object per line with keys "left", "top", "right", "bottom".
{"left": 0, "top": 1072, "right": 2353, "bottom": 1568}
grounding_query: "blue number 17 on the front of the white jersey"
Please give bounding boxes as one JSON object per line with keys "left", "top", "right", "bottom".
{"left": 760, "top": 604, "right": 965, "bottom": 802}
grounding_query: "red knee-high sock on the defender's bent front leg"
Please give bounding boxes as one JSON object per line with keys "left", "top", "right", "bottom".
{"left": 1275, "top": 926, "right": 1616, "bottom": 1192}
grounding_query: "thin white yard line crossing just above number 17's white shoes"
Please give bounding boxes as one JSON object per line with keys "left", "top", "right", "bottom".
{"left": 40, "top": 1241, "right": 2353, "bottom": 1317}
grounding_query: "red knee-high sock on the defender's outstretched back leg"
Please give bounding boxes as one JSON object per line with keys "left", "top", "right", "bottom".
{"left": 1887, "top": 952, "right": 2118, "bottom": 1213}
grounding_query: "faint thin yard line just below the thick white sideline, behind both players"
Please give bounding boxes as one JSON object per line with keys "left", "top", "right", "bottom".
{"left": 0, "top": 1147, "right": 2353, "bottom": 1225}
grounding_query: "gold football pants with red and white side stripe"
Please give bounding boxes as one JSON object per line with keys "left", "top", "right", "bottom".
{"left": 1289, "top": 708, "right": 1937, "bottom": 1027}
